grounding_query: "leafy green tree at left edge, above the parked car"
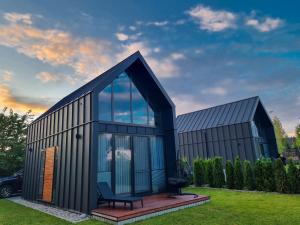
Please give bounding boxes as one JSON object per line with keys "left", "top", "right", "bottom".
{"left": 0, "top": 108, "right": 32, "bottom": 176}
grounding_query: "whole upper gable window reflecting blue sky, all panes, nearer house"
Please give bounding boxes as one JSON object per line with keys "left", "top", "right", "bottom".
{"left": 98, "top": 72, "right": 155, "bottom": 126}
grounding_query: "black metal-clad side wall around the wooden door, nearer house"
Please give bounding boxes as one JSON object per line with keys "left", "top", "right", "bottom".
{"left": 22, "top": 93, "right": 92, "bottom": 213}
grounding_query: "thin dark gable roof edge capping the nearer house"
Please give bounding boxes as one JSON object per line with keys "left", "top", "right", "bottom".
{"left": 36, "top": 51, "right": 175, "bottom": 121}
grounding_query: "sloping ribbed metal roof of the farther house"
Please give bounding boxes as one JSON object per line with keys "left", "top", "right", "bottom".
{"left": 176, "top": 96, "right": 261, "bottom": 133}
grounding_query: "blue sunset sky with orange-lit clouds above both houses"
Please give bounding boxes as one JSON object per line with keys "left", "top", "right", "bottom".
{"left": 0, "top": 0, "right": 300, "bottom": 134}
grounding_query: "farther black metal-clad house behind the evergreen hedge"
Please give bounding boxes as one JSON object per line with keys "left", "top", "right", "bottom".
{"left": 177, "top": 97, "right": 278, "bottom": 165}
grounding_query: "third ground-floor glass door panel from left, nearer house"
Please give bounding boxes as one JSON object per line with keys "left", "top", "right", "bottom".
{"left": 133, "top": 137, "right": 151, "bottom": 193}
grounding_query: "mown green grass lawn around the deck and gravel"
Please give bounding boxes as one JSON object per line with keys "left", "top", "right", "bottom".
{"left": 0, "top": 188, "right": 300, "bottom": 225}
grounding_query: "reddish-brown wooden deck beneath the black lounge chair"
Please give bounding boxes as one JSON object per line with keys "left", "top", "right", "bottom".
{"left": 92, "top": 193, "right": 209, "bottom": 225}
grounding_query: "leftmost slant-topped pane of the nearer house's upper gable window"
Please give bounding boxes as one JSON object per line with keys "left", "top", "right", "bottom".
{"left": 98, "top": 85, "right": 112, "bottom": 121}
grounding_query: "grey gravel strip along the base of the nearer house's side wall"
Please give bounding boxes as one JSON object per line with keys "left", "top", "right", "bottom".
{"left": 7, "top": 196, "right": 89, "bottom": 223}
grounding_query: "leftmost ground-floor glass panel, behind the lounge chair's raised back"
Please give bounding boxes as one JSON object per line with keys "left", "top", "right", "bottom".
{"left": 97, "top": 134, "right": 112, "bottom": 187}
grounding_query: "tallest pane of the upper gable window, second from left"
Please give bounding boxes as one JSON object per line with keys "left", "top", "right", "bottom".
{"left": 113, "top": 73, "right": 131, "bottom": 123}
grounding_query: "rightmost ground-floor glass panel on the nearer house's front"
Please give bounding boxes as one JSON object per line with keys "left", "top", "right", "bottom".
{"left": 150, "top": 137, "right": 166, "bottom": 192}
